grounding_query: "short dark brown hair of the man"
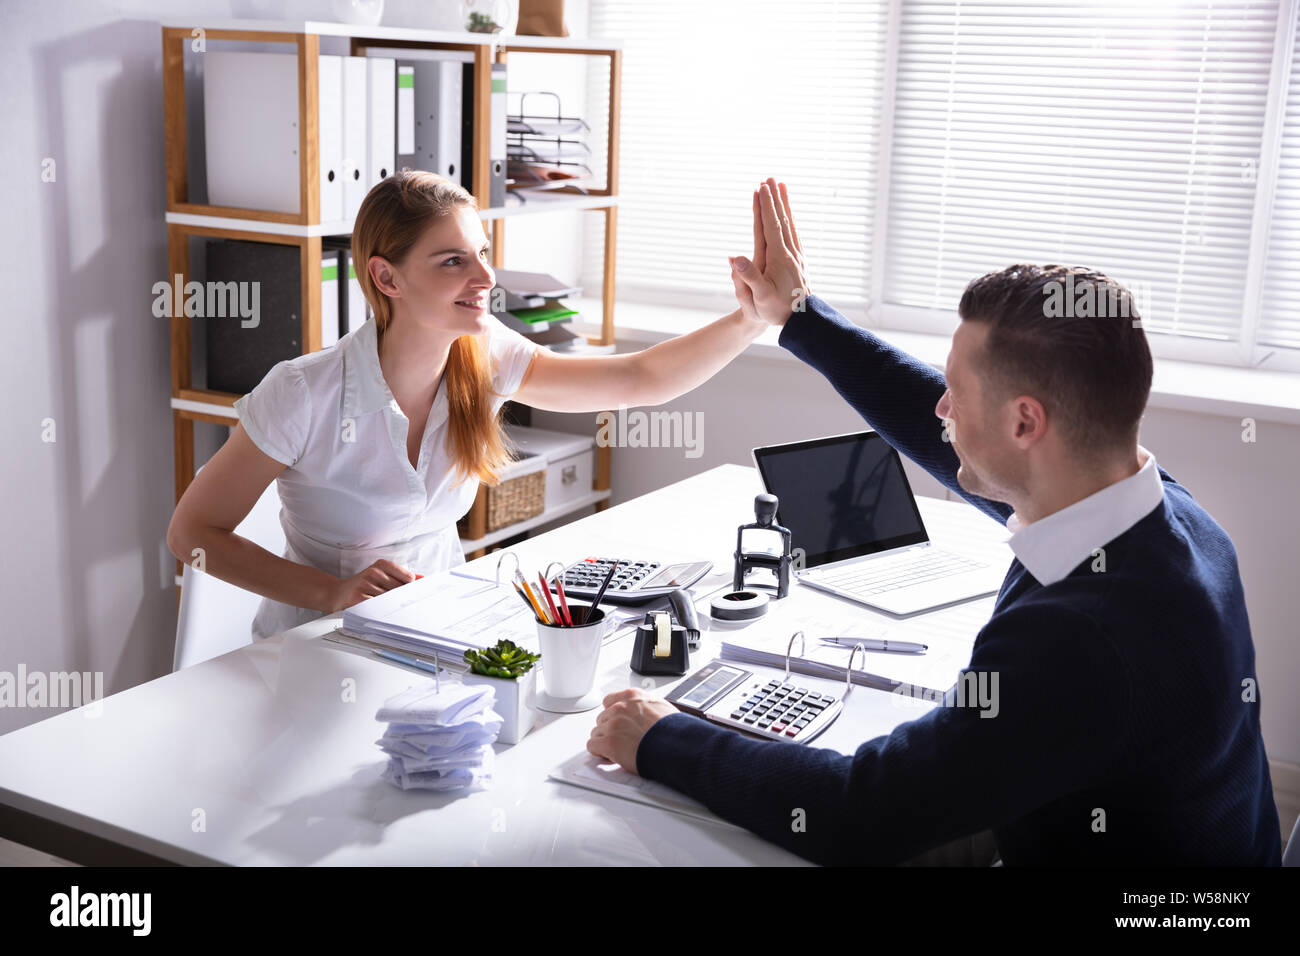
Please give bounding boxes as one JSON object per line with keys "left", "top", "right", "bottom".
{"left": 957, "top": 264, "right": 1152, "bottom": 455}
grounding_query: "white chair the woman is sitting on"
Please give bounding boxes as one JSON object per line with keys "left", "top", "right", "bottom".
{"left": 172, "top": 481, "right": 285, "bottom": 671}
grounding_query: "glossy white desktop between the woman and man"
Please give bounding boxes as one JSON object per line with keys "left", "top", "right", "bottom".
{"left": 0, "top": 466, "right": 1009, "bottom": 865}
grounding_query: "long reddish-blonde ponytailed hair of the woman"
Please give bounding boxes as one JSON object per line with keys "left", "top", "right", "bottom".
{"left": 352, "top": 169, "right": 511, "bottom": 485}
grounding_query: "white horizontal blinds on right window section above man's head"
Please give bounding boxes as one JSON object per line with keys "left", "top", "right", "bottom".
{"left": 883, "top": 0, "right": 1279, "bottom": 339}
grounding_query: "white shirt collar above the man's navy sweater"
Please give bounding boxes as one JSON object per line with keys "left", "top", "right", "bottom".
{"left": 1006, "top": 445, "right": 1165, "bottom": 587}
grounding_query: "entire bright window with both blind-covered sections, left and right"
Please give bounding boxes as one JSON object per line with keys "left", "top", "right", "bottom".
{"left": 592, "top": 0, "right": 1300, "bottom": 367}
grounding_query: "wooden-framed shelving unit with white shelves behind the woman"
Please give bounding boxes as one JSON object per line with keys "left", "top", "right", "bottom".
{"left": 163, "top": 20, "right": 623, "bottom": 557}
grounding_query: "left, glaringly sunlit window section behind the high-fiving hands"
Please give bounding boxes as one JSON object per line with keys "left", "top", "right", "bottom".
{"left": 584, "top": 0, "right": 887, "bottom": 311}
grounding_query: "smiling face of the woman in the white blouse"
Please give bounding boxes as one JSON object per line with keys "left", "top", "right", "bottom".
{"left": 384, "top": 207, "right": 497, "bottom": 334}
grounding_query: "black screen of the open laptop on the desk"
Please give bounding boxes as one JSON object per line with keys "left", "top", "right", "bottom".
{"left": 754, "top": 432, "right": 930, "bottom": 568}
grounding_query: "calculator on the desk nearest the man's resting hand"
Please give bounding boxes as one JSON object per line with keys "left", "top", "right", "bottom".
{"left": 667, "top": 661, "right": 844, "bottom": 744}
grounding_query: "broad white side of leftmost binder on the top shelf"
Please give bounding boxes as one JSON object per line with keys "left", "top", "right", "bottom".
{"left": 203, "top": 51, "right": 299, "bottom": 213}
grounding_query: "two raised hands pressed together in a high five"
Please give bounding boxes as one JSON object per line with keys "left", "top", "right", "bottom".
{"left": 731, "top": 178, "right": 810, "bottom": 325}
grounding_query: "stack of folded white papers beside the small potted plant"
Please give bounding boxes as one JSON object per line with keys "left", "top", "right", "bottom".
{"left": 374, "top": 682, "right": 502, "bottom": 790}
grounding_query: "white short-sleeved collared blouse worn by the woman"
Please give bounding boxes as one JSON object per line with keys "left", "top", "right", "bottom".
{"left": 235, "top": 317, "right": 541, "bottom": 637}
